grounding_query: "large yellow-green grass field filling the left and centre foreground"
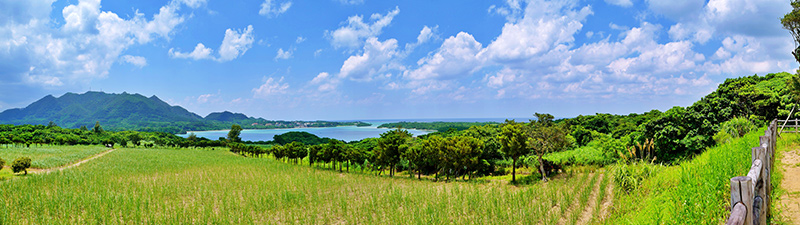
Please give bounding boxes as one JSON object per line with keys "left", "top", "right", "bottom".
{"left": 0, "top": 149, "right": 608, "bottom": 224}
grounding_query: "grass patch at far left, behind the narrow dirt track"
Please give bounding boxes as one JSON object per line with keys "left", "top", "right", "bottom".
{"left": 0, "top": 145, "right": 108, "bottom": 169}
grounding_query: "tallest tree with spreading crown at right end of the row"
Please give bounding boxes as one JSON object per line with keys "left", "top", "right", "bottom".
{"left": 527, "top": 113, "right": 569, "bottom": 181}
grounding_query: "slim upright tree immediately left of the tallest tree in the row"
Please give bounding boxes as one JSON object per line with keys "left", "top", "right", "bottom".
{"left": 500, "top": 120, "right": 530, "bottom": 182}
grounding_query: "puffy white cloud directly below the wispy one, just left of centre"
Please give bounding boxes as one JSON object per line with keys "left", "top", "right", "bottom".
{"left": 339, "top": 37, "right": 404, "bottom": 81}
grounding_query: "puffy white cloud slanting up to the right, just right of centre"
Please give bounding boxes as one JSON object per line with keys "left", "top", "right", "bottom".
{"left": 403, "top": 32, "right": 482, "bottom": 80}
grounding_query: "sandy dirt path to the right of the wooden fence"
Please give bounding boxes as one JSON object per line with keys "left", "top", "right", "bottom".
{"left": 778, "top": 149, "right": 800, "bottom": 224}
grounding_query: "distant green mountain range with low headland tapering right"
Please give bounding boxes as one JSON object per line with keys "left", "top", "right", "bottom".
{"left": 0, "top": 91, "right": 369, "bottom": 133}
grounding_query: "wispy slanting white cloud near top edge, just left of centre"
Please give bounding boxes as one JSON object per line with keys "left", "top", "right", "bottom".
{"left": 326, "top": 7, "right": 400, "bottom": 49}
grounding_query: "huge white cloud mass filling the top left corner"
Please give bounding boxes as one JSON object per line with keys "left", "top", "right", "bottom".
{"left": 0, "top": 0, "right": 205, "bottom": 86}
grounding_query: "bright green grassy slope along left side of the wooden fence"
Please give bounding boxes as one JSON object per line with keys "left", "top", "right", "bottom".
{"left": 605, "top": 129, "right": 764, "bottom": 224}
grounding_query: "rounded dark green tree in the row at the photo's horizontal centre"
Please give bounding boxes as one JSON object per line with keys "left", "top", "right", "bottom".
{"left": 378, "top": 128, "right": 411, "bottom": 176}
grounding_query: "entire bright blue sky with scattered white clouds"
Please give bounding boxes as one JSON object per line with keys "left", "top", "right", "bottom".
{"left": 0, "top": 0, "right": 798, "bottom": 120}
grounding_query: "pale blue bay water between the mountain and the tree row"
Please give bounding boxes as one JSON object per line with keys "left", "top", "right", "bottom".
{"left": 178, "top": 118, "right": 527, "bottom": 141}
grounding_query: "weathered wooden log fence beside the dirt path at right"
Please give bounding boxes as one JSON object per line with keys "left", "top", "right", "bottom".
{"left": 725, "top": 120, "right": 776, "bottom": 225}
